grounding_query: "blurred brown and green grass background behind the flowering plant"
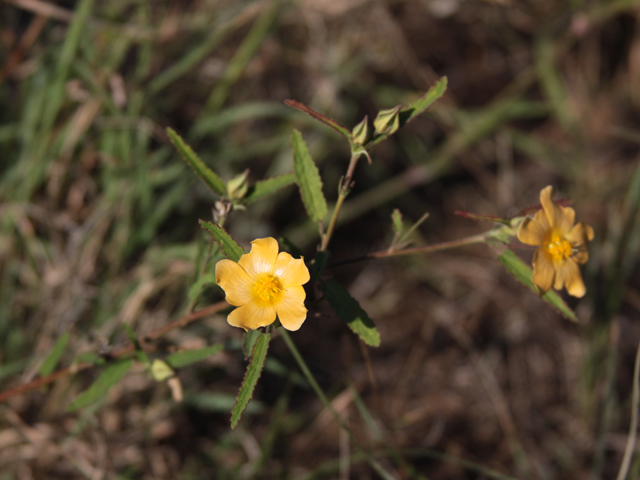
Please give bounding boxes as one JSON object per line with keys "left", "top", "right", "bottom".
{"left": 0, "top": 0, "right": 640, "bottom": 480}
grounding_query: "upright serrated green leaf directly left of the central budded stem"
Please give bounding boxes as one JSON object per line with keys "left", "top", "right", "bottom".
{"left": 291, "top": 130, "right": 327, "bottom": 222}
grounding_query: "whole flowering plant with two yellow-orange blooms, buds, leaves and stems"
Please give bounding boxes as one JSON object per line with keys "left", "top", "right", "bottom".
{"left": 0, "top": 78, "right": 593, "bottom": 478}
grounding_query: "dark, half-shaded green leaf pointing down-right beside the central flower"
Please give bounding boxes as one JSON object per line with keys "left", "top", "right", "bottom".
{"left": 320, "top": 278, "right": 380, "bottom": 347}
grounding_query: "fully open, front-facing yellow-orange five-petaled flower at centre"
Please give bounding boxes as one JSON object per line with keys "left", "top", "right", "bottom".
{"left": 216, "top": 237, "right": 310, "bottom": 331}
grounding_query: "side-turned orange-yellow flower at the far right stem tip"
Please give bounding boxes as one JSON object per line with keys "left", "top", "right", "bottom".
{"left": 518, "top": 186, "right": 593, "bottom": 297}
